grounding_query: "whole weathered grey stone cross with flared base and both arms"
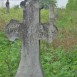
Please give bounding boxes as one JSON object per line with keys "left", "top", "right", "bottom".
{"left": 6, "top": 0, "right": 57, "bottom": 77}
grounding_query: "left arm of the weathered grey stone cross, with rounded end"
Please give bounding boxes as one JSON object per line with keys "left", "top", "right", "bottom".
{"left": 6, "top": 19, "right": 22, "bottom": 41}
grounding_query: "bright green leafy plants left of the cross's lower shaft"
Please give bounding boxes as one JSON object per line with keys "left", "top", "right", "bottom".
{"left": 0, "top": 32, "right": 21, "bottom": 77}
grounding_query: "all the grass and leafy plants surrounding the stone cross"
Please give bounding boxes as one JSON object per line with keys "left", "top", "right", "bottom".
{"left": 0, "top": 9, "right": 77, "bottom": 77}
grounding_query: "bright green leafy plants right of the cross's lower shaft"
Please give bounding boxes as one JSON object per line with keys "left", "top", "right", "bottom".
{"left": 41, "top": 42, "right": 77, "bottom": 77}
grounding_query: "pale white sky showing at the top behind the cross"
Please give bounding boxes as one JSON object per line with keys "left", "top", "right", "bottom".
{"left": 0, "top": 0, "right": 68, "bottom": 8}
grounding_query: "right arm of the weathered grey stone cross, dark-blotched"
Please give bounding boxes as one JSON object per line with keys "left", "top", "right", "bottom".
{"left": 39, "top": 24, "right": 58, "bottom": 43}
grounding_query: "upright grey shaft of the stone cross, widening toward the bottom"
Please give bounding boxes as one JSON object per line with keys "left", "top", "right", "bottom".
{"left": 16, "top": 1, "right": 43, "bottom": 77}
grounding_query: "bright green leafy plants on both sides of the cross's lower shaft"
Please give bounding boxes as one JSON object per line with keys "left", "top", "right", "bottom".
{"left": 0, "top": 32, "right": 77, "bottom": 77}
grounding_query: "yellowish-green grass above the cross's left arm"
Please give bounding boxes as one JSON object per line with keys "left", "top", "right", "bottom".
{"left": 0, "top": 8, "right": 22, "bottom": 30}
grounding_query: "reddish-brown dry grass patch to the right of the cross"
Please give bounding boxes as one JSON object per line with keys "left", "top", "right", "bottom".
{"left": 52, "top": 29, "right": 77, "bottom": 49}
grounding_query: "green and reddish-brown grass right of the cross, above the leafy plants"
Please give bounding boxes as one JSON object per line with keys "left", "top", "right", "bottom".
{"left": 54, "top": 10, "right": 77, "bottom": 49}
